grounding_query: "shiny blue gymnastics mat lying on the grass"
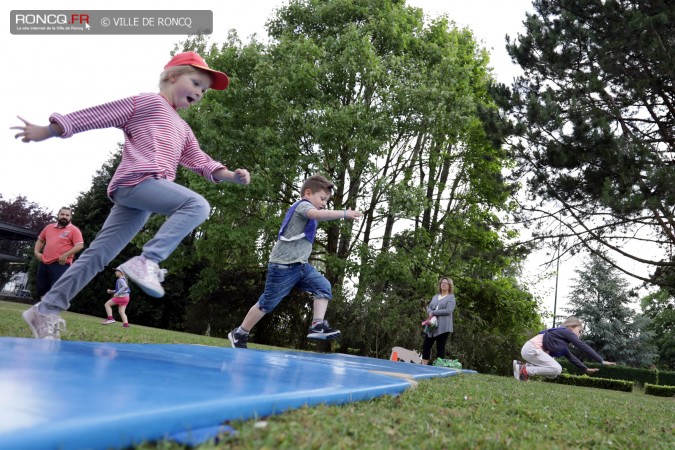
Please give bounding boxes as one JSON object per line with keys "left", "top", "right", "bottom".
{"left": 0, "top": 338, "right": 475, "bottom": 450}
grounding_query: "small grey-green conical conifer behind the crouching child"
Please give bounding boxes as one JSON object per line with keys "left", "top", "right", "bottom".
{"left": 568, "top": 251, "right": 657, "bottom": 367}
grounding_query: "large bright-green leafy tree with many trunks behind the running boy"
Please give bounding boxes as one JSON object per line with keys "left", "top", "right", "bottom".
{"left": 178, "top": 0, "right": 537, "bottom": 366}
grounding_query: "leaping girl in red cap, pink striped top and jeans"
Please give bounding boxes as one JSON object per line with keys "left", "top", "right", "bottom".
{"left": 12, "top": 52, "right": 250, "bottom": 339}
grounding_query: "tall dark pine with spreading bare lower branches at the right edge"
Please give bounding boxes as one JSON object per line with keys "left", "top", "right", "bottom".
{"left": 507, "top": 0, "right": 675, "bottom": 286}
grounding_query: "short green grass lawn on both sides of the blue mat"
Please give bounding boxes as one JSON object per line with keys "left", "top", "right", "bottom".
{"left": 0, "top": 302, "right": 675, "bottom": 450}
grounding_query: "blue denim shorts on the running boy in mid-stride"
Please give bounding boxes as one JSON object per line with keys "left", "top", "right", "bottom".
{"left": 258, "top": 263, "right": 333, "bottom": 313}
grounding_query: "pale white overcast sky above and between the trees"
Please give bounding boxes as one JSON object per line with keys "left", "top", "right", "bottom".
{"left": 0, "top": 0, "right": 612, "bottom": 324}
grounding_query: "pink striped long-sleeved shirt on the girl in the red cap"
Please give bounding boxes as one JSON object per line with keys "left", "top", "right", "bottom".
{"left": 49, "top": 94, "right": 225, "bottom": 195}
